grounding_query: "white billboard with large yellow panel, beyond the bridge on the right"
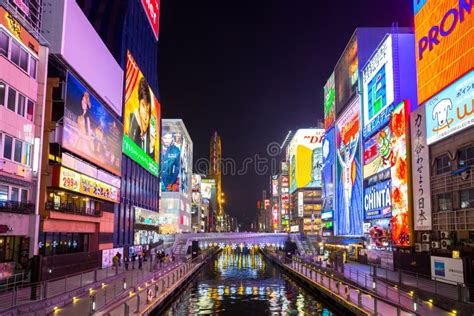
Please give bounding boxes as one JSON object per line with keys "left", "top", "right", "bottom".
{"left": 288, "top": 129, "right": 324, "bottom": 193}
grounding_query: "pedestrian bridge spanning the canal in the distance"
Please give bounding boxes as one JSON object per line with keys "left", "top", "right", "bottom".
{"left": 172, "top": 232, "right": 289, "bottom": 255}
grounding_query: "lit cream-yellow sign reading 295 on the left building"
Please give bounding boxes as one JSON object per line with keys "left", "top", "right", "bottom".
{"left": 53, "top": 167, "right": 120, "bottom": 203}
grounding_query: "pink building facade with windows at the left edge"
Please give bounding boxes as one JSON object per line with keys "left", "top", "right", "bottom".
{"left": 0, "top": 1, "right": 48, "bottom": 279}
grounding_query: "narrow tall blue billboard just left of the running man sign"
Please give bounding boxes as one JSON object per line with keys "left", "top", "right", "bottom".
{"left": 321, "top": 128, "right": 336, "bottom": 198}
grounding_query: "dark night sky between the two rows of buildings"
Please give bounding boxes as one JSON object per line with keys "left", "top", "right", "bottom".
{"left": 158, "top": 0, "right": 413, "bottom": 230}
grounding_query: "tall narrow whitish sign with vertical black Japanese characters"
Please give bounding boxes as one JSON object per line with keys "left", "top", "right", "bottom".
{"left": 410, "top": 106, "right": 432, "bottom": 230}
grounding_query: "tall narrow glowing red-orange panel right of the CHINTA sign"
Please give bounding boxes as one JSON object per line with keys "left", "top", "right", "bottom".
{"left": 390, "top": 102, "right": 411, "bottom": 247}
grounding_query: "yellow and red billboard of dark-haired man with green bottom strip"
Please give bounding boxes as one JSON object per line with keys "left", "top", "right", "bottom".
{"left": 122, "top": 51, "right": 160, "bottom": 176}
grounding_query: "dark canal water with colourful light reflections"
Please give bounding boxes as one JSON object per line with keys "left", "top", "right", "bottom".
{"left": 160, "top": 249, "right": 336, "bottom": 316}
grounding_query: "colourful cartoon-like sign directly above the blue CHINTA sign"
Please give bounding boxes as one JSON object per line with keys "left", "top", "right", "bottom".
{"left": 364, "top": 126, "right": 392, "bottom": 179}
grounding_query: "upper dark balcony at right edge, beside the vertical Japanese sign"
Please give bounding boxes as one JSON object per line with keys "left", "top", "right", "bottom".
{"left": 431, "top": 166, "right": 474, "bottom": 195}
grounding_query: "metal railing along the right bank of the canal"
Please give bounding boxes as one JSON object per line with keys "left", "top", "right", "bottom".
{"left": 267, "top": 252, "right": 417, "bottom": 315}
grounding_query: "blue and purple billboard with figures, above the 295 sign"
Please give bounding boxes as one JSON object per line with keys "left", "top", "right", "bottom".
{"left": 62, "top": 72, "right": 123, "bottom": 175}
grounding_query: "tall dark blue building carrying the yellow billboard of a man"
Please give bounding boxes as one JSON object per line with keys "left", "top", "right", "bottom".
{"left": 78, "top": 0, "right": 161, "bottom": 249}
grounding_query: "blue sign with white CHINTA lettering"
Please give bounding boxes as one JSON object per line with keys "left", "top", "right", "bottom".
{"left": 364, "top": 180, "right": 392, "bottom": 220}
